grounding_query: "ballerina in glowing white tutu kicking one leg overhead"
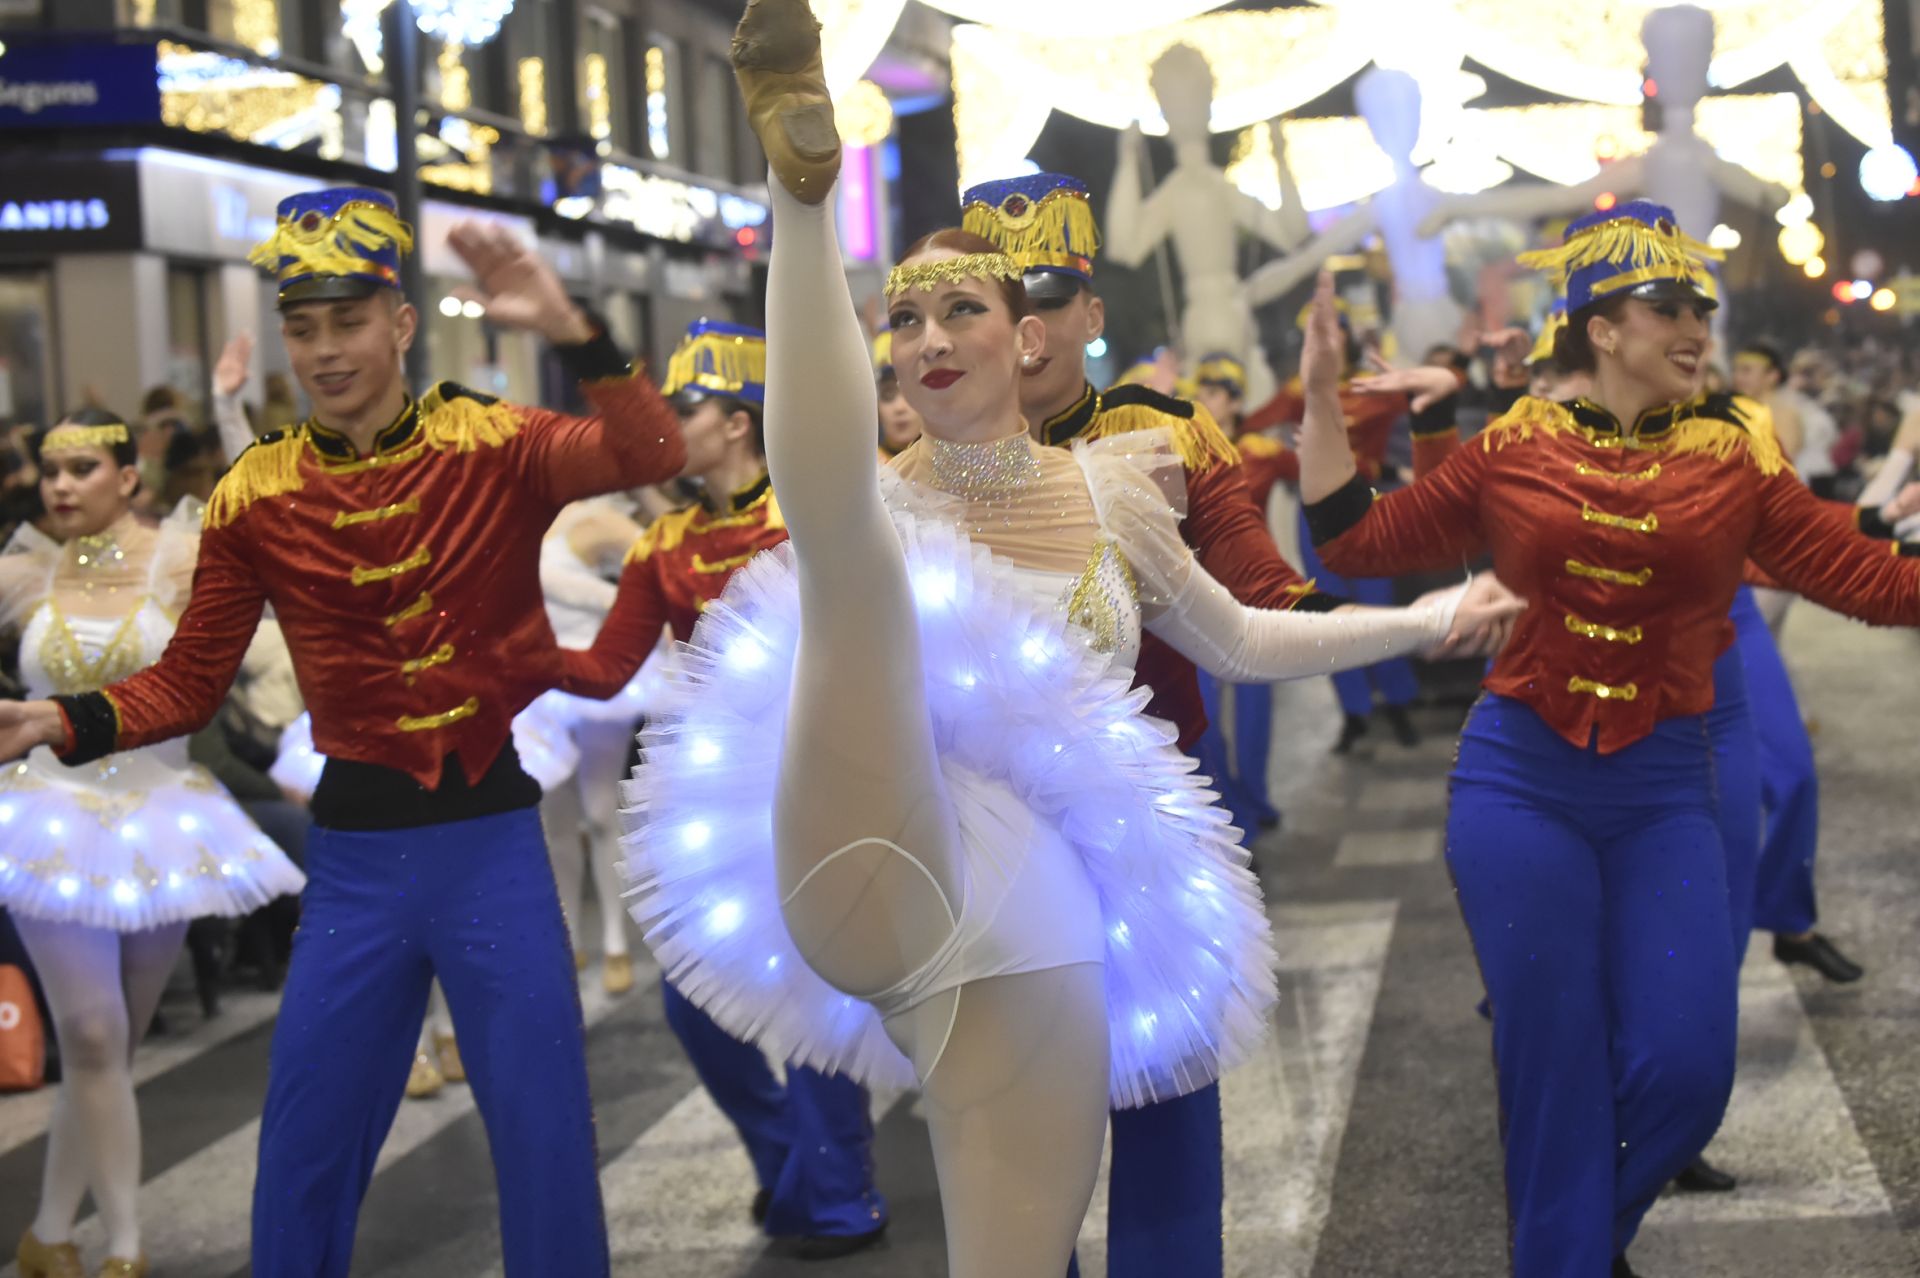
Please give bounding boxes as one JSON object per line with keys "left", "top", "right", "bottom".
{"left": 632, "top": 0, "right": 1513, "bottom": 1278}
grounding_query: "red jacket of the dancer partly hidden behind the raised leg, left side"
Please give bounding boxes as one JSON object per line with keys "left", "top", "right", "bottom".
{"left": 561, "top": 474, "right": 787, "bottom": 698}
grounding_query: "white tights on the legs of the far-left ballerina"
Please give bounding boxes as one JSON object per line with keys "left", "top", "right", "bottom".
{"left": 13, "top": 917, "right": 186, "bottom": 1261}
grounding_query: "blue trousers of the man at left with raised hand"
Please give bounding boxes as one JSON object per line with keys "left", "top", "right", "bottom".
{"left": 253, "top": 808, "right": 609, "bottom": 1278}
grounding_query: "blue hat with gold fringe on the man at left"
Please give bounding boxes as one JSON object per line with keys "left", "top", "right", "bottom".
{"left": 248, "top": 186, "right": 413, "bottom": 309}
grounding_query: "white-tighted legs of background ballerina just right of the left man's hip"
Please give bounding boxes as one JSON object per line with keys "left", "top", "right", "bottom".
{"left": 540, "top": 720, "right": 634, "bottom": 956}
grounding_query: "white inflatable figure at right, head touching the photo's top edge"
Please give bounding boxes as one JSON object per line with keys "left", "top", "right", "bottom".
{"left": 1421, "top": 4, "right": 1791, "bottom": 278}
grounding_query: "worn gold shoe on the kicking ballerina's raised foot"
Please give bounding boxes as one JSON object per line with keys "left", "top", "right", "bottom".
{"left": 732, "top": 0, "right": 839, "bottom": 203}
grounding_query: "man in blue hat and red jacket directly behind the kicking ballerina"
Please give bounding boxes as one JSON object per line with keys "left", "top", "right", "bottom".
{"left": 962, "top": 173, "right": 1498, "bottom": 1278}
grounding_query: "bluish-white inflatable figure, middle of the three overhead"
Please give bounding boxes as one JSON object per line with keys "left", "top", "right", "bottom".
{"left": 1246, "top": 67, "right": 1461, "bottom": 359}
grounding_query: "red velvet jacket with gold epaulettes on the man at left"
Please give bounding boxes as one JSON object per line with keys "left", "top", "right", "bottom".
{"left": 61, "top": 349, "right": 685, "bottom": 791}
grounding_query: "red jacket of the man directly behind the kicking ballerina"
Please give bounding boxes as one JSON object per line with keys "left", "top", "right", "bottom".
{"left": 1041, "top": 386, "right": 1346, "bottom": 748}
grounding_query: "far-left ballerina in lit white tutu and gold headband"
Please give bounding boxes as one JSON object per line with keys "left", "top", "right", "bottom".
{"left": 0, "top": 409, "right": 305, "bottom": 1276}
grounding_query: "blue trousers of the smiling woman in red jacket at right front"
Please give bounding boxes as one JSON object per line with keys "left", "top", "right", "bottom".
{"left": 1448, "top": 697, "right": 1736, "bottom": 1278}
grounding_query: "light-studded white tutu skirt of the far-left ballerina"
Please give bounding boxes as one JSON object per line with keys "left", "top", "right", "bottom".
{"left": 0, "top": 743, "right": 307, "bottom": 933}
